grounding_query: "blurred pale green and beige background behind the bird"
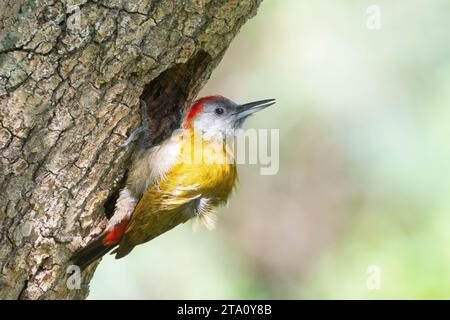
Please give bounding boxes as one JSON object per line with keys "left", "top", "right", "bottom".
{"left": 90, "top": 0, "right": 450, "bottom": 299}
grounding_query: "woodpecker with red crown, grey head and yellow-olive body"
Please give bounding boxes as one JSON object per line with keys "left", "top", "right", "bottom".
{"left": 72, "top": 95, "right": 275, "bottom": 270}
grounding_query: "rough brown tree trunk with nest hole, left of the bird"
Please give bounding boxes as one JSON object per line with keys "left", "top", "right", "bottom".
{"left": 0, "top": 0, "right": 261, "bottom": 299}
